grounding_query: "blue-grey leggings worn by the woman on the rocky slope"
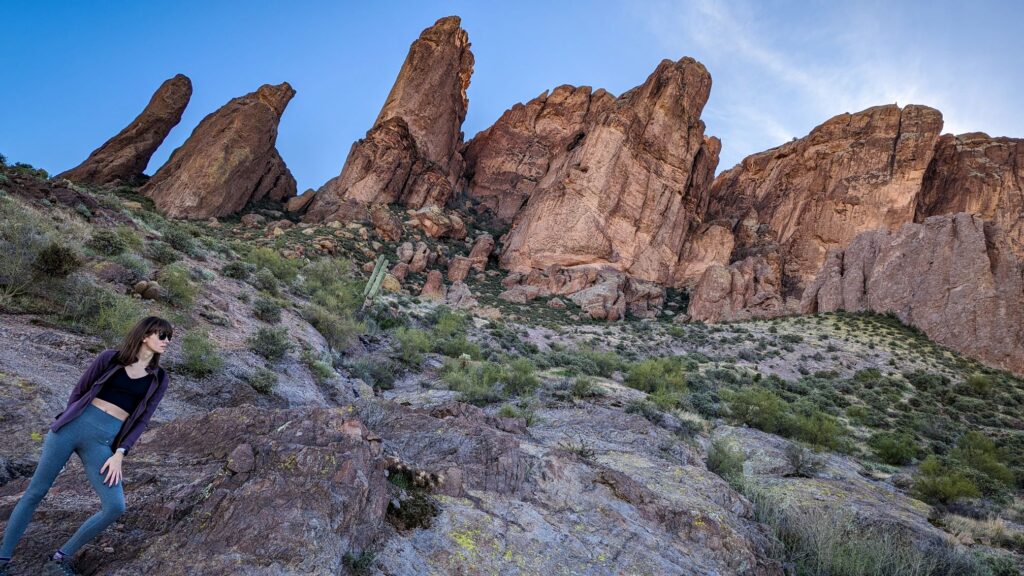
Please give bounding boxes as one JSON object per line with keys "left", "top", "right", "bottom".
{"left": 0, "top": 404, "right": 125, "bottom": 558}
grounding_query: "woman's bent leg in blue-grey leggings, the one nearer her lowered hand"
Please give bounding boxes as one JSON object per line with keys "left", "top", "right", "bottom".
{"left": 54, "top": 429, "right": 125, "bottom": 558}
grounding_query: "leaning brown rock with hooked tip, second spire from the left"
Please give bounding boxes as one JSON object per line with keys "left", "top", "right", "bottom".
{"left": 140, "top": 82, "right": 296, "bottom": 218}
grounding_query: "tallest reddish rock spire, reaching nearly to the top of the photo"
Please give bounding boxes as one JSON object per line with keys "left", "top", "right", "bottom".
{"left": 303, "top": 16, "right": 473, "bottom": 222}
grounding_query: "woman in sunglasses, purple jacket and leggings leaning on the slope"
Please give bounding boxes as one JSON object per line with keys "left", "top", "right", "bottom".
{"left": 0, "top": 316, "right": 173, "bottom": 576}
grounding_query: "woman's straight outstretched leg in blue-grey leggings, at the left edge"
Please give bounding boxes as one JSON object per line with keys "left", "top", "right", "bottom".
{"left": 0, "top": 423, "right": 75, "bottom": 558}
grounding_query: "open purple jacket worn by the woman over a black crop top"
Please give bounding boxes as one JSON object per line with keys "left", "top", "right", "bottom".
{"left": 50, "top": 348, "right": 168, "bottom": 455}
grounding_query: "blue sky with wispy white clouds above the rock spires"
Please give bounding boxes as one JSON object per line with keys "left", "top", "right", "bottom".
{"left": 0, "top": 0, "right": 1024, "bottom": 192}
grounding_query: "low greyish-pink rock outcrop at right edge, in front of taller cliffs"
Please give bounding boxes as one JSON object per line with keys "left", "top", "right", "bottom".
{"left": 801, "top": 212, "right": 1024, "bottom": 374}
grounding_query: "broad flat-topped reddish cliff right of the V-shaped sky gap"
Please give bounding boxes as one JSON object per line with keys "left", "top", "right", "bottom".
{"left": 708, "top": 105, "right": 942, "bottom": 297}
